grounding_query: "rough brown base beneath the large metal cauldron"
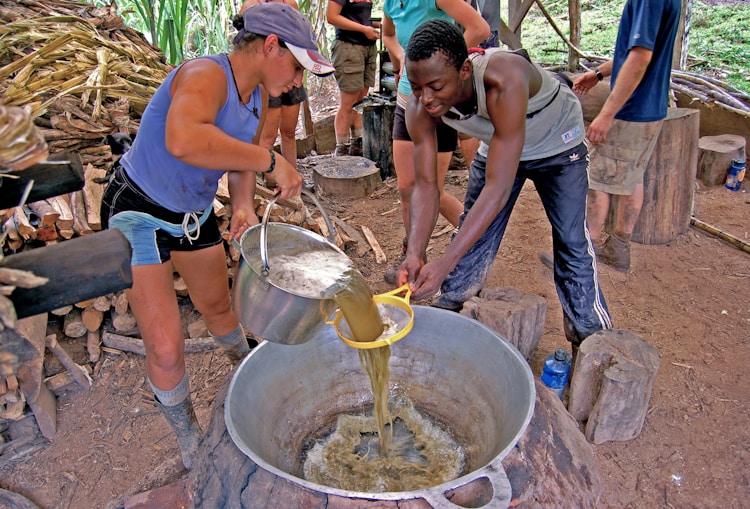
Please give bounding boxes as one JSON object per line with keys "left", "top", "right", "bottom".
{"left": 189, "top": 377, "right": 601, "bottom": 509}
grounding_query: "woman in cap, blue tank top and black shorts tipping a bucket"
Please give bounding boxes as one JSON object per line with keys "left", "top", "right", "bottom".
{"left": 102, "top": 3, "right": 333, "bottom": 468}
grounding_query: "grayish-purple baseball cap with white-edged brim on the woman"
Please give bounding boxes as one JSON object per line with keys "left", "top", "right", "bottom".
{"left": 237, "top": 2, "right": 335, "bottom": 76}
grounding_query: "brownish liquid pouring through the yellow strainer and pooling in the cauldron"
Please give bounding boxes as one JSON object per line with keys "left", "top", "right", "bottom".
{"left": 303, "top": 269, "right": 464, "bottom": 492}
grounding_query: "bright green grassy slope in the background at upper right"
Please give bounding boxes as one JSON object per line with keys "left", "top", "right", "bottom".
{"left": 521, "top": 0, "right": 750, "bottom": 93}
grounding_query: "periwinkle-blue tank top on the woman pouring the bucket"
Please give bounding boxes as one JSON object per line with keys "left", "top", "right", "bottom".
{"left": 120, "top": 54, "right": 261, "bottom": 212}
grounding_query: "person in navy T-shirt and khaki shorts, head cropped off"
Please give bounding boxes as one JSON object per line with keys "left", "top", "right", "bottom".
{"left": 573, "top": 0, "right": 681, "bottom": 272}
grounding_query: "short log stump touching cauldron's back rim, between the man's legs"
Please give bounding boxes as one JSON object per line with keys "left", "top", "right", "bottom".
{"left": 461, "top": 287, "right": 547, "bottom": 359}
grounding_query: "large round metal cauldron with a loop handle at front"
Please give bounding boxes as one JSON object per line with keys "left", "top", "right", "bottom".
{"left": 224, "top": 306, "right": 535, "bottom": 508}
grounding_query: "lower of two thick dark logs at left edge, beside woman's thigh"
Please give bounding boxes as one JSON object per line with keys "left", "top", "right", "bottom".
{"left": 0, "top": 230, "right": 133, "bottom": 318}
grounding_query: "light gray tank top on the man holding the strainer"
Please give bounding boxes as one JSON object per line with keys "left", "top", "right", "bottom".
{"left": 442, "top": 48, "right": 586, "bottom": 161}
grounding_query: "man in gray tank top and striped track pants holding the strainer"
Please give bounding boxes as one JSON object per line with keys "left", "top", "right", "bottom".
{"left": 398, "top": 20, "right": 612, "bottom": 350}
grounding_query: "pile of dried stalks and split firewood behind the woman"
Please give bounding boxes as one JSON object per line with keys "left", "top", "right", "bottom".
{"left": 0, "top": 0, "right": 390, "bottom": 396}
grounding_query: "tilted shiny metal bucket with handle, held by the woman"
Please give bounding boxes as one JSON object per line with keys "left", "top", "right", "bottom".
{"left": 232, "top": 191, "right": 351, "bottom": 345}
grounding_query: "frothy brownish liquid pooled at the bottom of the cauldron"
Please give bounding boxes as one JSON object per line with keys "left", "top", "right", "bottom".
{"left": 303, "top": 398, "right": 464, "bottom": 493}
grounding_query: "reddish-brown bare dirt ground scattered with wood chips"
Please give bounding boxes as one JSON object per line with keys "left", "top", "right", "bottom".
{"left": 0, "top": 78, "right": 750, "bottom": 509}
